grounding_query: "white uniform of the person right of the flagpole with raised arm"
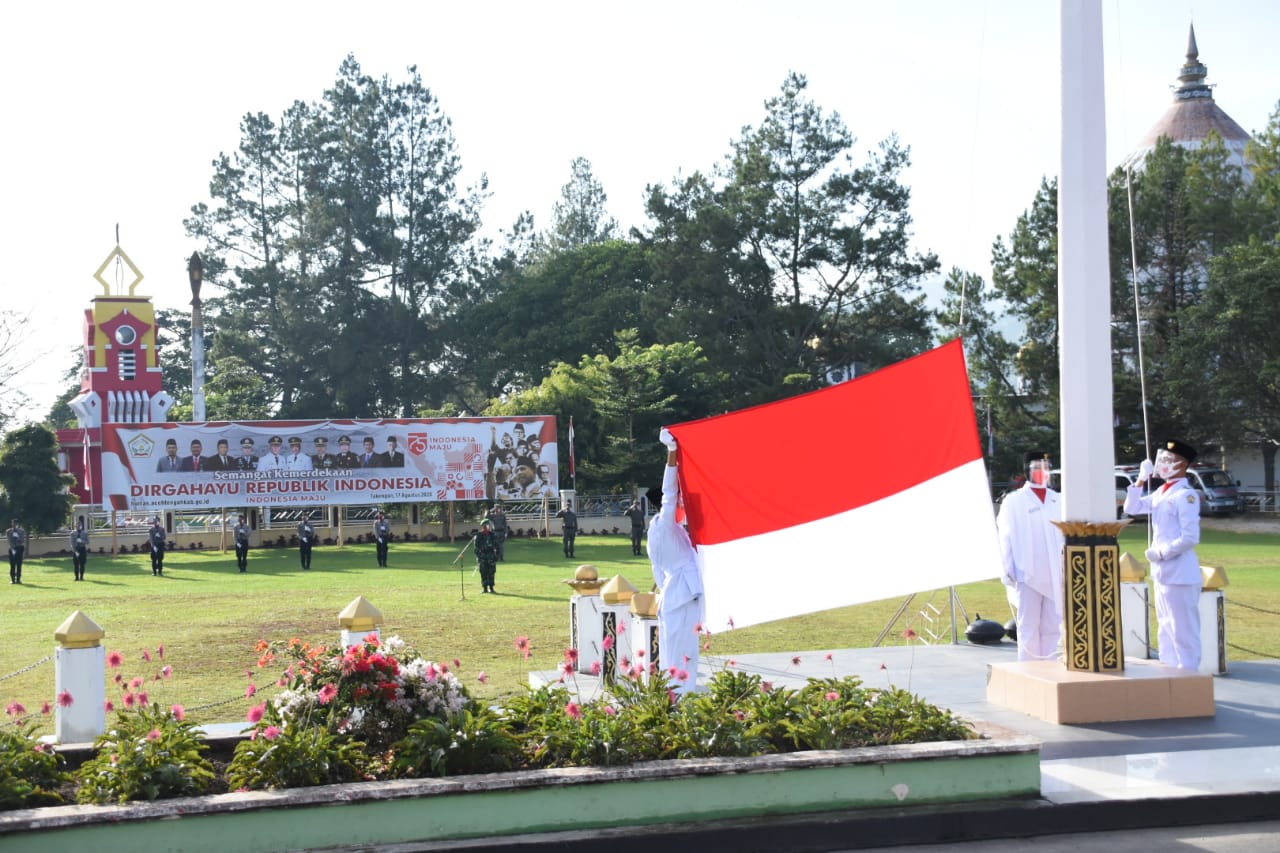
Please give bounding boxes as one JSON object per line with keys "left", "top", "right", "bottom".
{"left": 1124, "top": 478, "right": 1204, "bottom": 670}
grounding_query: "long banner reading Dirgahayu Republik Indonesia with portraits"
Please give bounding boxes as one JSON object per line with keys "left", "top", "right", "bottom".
{"left": 101, "top": 415, "right": 559, "bottom": 512}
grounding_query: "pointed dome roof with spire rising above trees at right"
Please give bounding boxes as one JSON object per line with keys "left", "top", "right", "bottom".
{"left": 1120, "top": 24, "right": 1252, "bottom": 175}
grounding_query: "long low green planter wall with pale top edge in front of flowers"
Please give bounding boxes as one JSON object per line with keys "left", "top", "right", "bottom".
{"left": 0, "top": 727, "right": 1041, "bottom": 853}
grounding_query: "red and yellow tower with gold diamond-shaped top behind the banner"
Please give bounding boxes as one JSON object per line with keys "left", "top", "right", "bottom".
{"left": 58, "top": 246, "right": 173, "bottom": 503}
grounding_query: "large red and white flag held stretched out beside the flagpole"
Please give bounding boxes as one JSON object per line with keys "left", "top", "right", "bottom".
{"left": 671, "top": 341, "right": 1000, "bottom": 631}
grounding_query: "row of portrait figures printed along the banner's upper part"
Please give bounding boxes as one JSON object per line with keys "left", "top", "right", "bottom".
{"left": 156, "top": 435, "right": 404, "bottom": 474}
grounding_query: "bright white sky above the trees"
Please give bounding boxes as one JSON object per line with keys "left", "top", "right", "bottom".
{"left": 0, "top": 0, "right": 1280, "bottom": 419}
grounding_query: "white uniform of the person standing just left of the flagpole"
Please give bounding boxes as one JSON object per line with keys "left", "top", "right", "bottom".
{"left": 996, "top": 483, "right": 1064, "bottom": 661}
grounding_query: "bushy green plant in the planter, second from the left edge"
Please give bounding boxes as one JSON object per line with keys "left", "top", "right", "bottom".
{"left": 76, "top": 703, "right": 215, "bottom": 803}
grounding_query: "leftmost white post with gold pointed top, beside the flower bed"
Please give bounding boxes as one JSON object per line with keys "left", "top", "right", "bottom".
{"left": 54, "top": 610, "right": 106, "bottom": 743}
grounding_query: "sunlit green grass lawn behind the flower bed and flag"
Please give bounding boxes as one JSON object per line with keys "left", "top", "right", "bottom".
{"left": 0, "top": 525, "right": 1280, "bottom": 722}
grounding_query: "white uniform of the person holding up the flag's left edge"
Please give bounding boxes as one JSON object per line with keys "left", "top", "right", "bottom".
{"left": 649, "top": 465, "right": 705, "bottom": 693}
